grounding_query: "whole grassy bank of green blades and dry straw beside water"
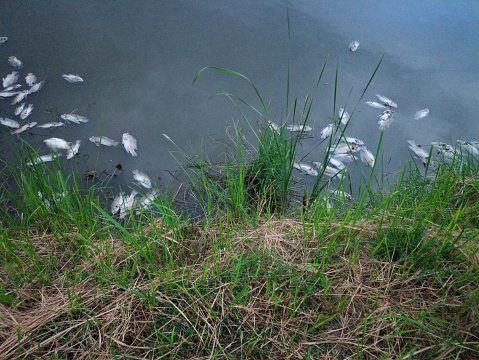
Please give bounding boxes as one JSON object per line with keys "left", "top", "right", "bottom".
{"left": 0, "top": 69, "right": 479, "bottom": 359}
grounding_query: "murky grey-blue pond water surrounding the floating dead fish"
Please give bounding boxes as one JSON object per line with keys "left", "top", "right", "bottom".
{"left": 0, "top": 0, "right": 479, "bottom": 198}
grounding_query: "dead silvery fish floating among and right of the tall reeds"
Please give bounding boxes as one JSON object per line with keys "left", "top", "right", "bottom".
{"left": 268, "top": 41, "right": 479, "bottom": 205}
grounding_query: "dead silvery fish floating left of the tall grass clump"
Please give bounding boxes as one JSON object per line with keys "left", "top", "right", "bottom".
{"left": 0, "top": 37, "right": 158, "bottom": 219}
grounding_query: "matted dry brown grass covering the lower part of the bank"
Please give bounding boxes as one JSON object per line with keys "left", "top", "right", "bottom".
{"left": 0, "top": 218, "right": 479, "bottom": 359}
